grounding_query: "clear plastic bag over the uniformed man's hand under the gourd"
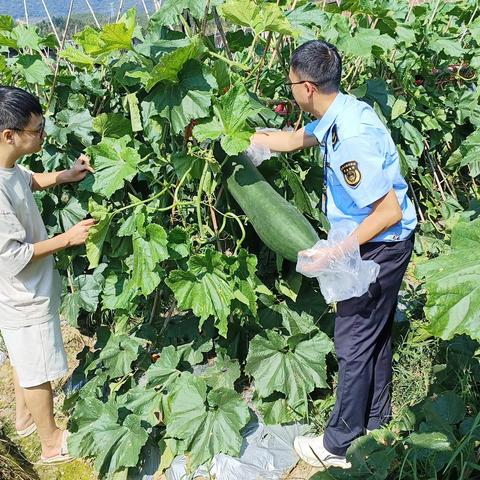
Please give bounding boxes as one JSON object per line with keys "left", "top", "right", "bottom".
{"left": 297, "top": 221, "right": 380, "bottom": 303}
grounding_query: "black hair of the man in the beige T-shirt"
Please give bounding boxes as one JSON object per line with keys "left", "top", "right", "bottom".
{"left": 0, "top": 86, "right": 43, "bottom": 132}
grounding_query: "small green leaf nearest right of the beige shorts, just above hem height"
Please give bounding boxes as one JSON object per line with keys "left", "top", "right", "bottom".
{"left": 98, "top": 334, "right": 145, "bottom": 378}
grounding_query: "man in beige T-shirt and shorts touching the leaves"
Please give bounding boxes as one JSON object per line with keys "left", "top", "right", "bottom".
{"left": 0, "top": 86, "right": 94, "bottom": 464}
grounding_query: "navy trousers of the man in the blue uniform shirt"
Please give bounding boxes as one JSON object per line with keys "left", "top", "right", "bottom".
{"left": 323, "top": 234, "right": 414, "bottom": 455}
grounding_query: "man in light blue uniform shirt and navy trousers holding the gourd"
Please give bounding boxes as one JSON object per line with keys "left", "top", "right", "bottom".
{"left": 252, "top": 40, "right": 417, "bottom": 468}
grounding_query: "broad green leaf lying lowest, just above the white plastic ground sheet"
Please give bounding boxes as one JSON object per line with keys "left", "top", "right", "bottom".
{"left": 166, "top": 373, "right": 250, "bottom": 467}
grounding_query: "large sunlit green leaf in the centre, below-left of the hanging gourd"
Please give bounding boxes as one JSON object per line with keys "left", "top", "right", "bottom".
{"left": 166, "top": 250, "right": 235, "bottom": 336}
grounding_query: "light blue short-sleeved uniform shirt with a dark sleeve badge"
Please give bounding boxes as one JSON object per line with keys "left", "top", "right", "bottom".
{"left": 305, "top": 93, "right": 417, "bottom": 242}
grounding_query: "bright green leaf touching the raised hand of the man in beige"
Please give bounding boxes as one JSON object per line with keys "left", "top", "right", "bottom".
{"left": 83, "top": 136, "right": 141, "bottom": 198}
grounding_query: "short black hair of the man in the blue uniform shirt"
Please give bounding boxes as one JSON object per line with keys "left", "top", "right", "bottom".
{"left": 290, "top": 40, "right": 342, "bottom": 93}
